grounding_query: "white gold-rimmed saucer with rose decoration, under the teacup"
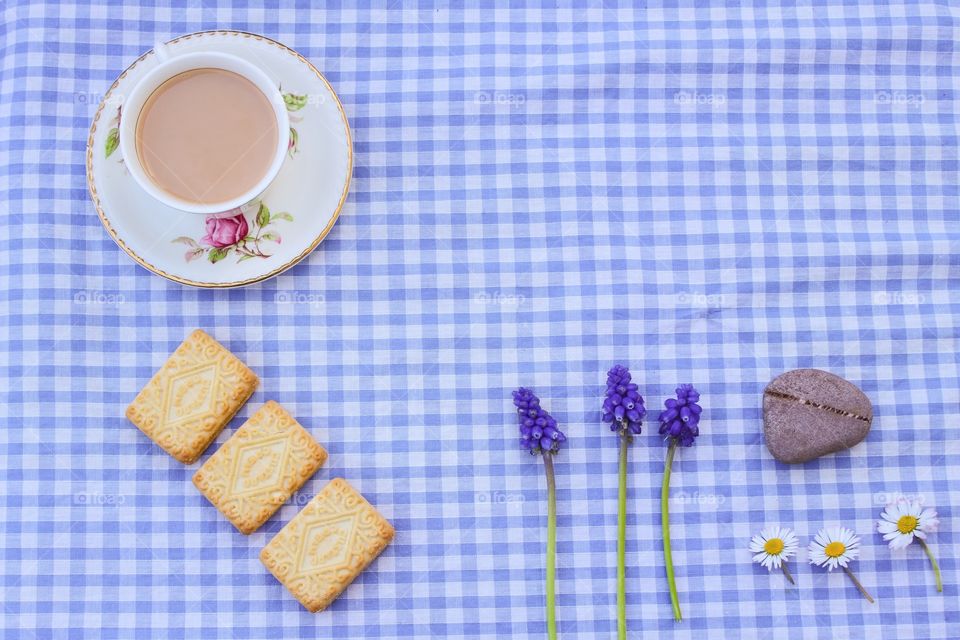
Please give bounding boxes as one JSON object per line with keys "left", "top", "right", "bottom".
{"left": 87, "top": 31, "right": 353, "bottom": 288}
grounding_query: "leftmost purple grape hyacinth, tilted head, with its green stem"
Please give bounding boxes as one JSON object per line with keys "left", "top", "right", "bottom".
{"left": 513, "top": 387, "right": 567, "bottom": 640}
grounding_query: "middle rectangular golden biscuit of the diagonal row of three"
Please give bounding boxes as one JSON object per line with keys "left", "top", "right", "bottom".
{"left": 193, "top": 400, "right": 327, "bottom": 535}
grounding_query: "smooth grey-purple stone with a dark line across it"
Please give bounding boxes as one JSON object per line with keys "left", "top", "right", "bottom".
{"left": 763, "top": 369, "right": 873, "bottom": 464}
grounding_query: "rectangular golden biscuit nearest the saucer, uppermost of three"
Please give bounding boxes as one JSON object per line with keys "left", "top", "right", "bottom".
{"left": 126, "top": 329, "right": 258, "bottom": 464}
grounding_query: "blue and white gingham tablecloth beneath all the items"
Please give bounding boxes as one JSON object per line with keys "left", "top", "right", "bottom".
{"left": 0, "top": 0, "right": 960, "bottom": 639}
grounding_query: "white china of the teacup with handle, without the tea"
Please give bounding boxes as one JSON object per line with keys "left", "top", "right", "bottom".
{"left": 120, "top": 45, "right": 290, "bottom": 215}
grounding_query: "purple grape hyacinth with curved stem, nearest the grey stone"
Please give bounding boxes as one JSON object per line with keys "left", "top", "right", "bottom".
{"left": 660, "top": 384, "right": 703, "bottom": 622}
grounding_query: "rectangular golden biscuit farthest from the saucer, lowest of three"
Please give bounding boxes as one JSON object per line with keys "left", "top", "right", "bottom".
{"left": 260, "top": 478, "right": 394, "bottom": 612}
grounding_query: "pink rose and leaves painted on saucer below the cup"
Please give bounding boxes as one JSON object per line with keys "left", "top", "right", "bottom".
{"left": 171, "top": 202, "right": 293, "bottom": 264}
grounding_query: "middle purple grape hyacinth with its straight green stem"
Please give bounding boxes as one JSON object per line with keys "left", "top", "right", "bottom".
{"left": 603, "top": 364, "right": 647, "bottom": 640}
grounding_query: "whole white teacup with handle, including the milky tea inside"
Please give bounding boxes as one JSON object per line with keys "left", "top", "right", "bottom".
{"left": 120, "top": 46, "right": 290, "bottom": 214}
